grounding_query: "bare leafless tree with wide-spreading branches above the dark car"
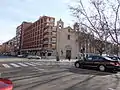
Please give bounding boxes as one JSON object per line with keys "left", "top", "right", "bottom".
{"left": 70, "top": 0, "right": 120, "bottom": 54}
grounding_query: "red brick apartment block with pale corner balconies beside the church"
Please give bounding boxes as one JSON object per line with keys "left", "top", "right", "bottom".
{"left": 21, "top": 16, "right": 56, "bottom": 56}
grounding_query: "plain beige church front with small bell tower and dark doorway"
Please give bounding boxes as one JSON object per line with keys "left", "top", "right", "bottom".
{"left": 56, "top": 19, "right": 79, "bottom": 59}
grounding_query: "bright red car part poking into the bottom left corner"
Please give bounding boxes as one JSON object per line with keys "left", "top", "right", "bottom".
{"left": 0, "top": 78, "right": 13, "bottom": 90}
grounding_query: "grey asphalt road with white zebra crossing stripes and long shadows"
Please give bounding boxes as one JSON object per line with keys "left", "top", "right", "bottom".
{"left": 0, "top": 58, "right": 120, "bottom": 90}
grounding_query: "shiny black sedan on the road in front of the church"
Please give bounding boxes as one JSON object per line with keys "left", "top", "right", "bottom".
{"left": 75, "top": 55, "right": 120, "bottom": 71}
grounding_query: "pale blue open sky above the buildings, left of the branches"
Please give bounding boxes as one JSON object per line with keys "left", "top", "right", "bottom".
{"left": 0, "top": 0, "right": 77, "bottom": 44}
